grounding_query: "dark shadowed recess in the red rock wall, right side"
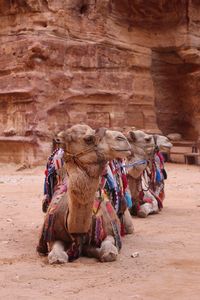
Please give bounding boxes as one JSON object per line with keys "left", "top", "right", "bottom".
{"left": 151, "top": 49, "right": 197, "bottom": 139}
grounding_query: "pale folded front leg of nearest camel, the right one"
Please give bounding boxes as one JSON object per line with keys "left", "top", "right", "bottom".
{"left": 99, "top": 236, "right": 118, "bottom": 262}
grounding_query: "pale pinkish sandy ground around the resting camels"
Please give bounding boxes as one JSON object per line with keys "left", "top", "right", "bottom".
{"left": 0, "top": 164, "right": 200, "bottom": 300}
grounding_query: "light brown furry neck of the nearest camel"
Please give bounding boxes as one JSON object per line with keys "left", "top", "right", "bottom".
{"left": 67, "top": 163, "right": 104, "bottom": 233}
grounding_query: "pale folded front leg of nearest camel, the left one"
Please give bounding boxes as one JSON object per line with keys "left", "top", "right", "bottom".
{"left": 48, "top": 241, "right": 68, "bottom": 264}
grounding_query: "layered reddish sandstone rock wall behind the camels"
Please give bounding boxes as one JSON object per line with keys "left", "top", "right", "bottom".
{"left": 0, "top": 0, "right": 200, "bottom": 164}
